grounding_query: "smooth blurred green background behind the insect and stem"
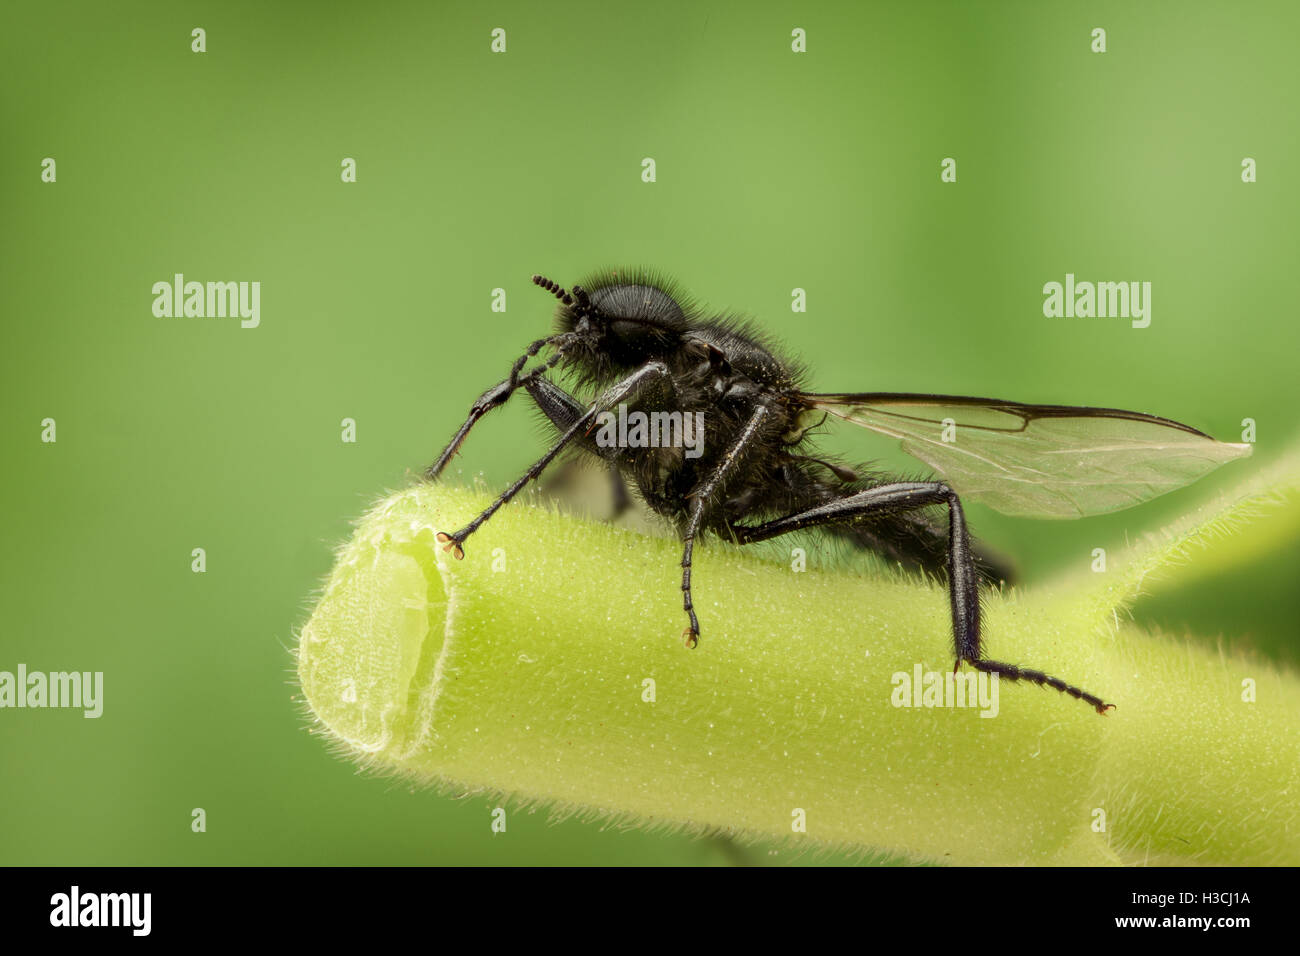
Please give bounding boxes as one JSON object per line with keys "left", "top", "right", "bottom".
{"left": 0, "top": 1, "right": 1300, "bottom": 864}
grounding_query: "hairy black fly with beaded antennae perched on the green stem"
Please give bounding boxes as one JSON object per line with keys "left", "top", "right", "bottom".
{"left": 425, "top": 271, "right": 1251, "bottom": 713}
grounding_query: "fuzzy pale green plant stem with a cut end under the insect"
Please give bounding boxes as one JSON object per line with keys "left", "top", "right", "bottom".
{"left": 299, "top": 485, "right": 1300, "bottom": 865}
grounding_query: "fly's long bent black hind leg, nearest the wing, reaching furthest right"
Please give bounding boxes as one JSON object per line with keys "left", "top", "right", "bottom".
{"left": 732, "top": 481, "right": 1114, "bottom": 714}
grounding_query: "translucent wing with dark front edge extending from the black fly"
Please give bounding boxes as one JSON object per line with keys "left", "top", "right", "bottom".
{"left": 803, "top": 393, "right": 1251, "bottom": 518}
